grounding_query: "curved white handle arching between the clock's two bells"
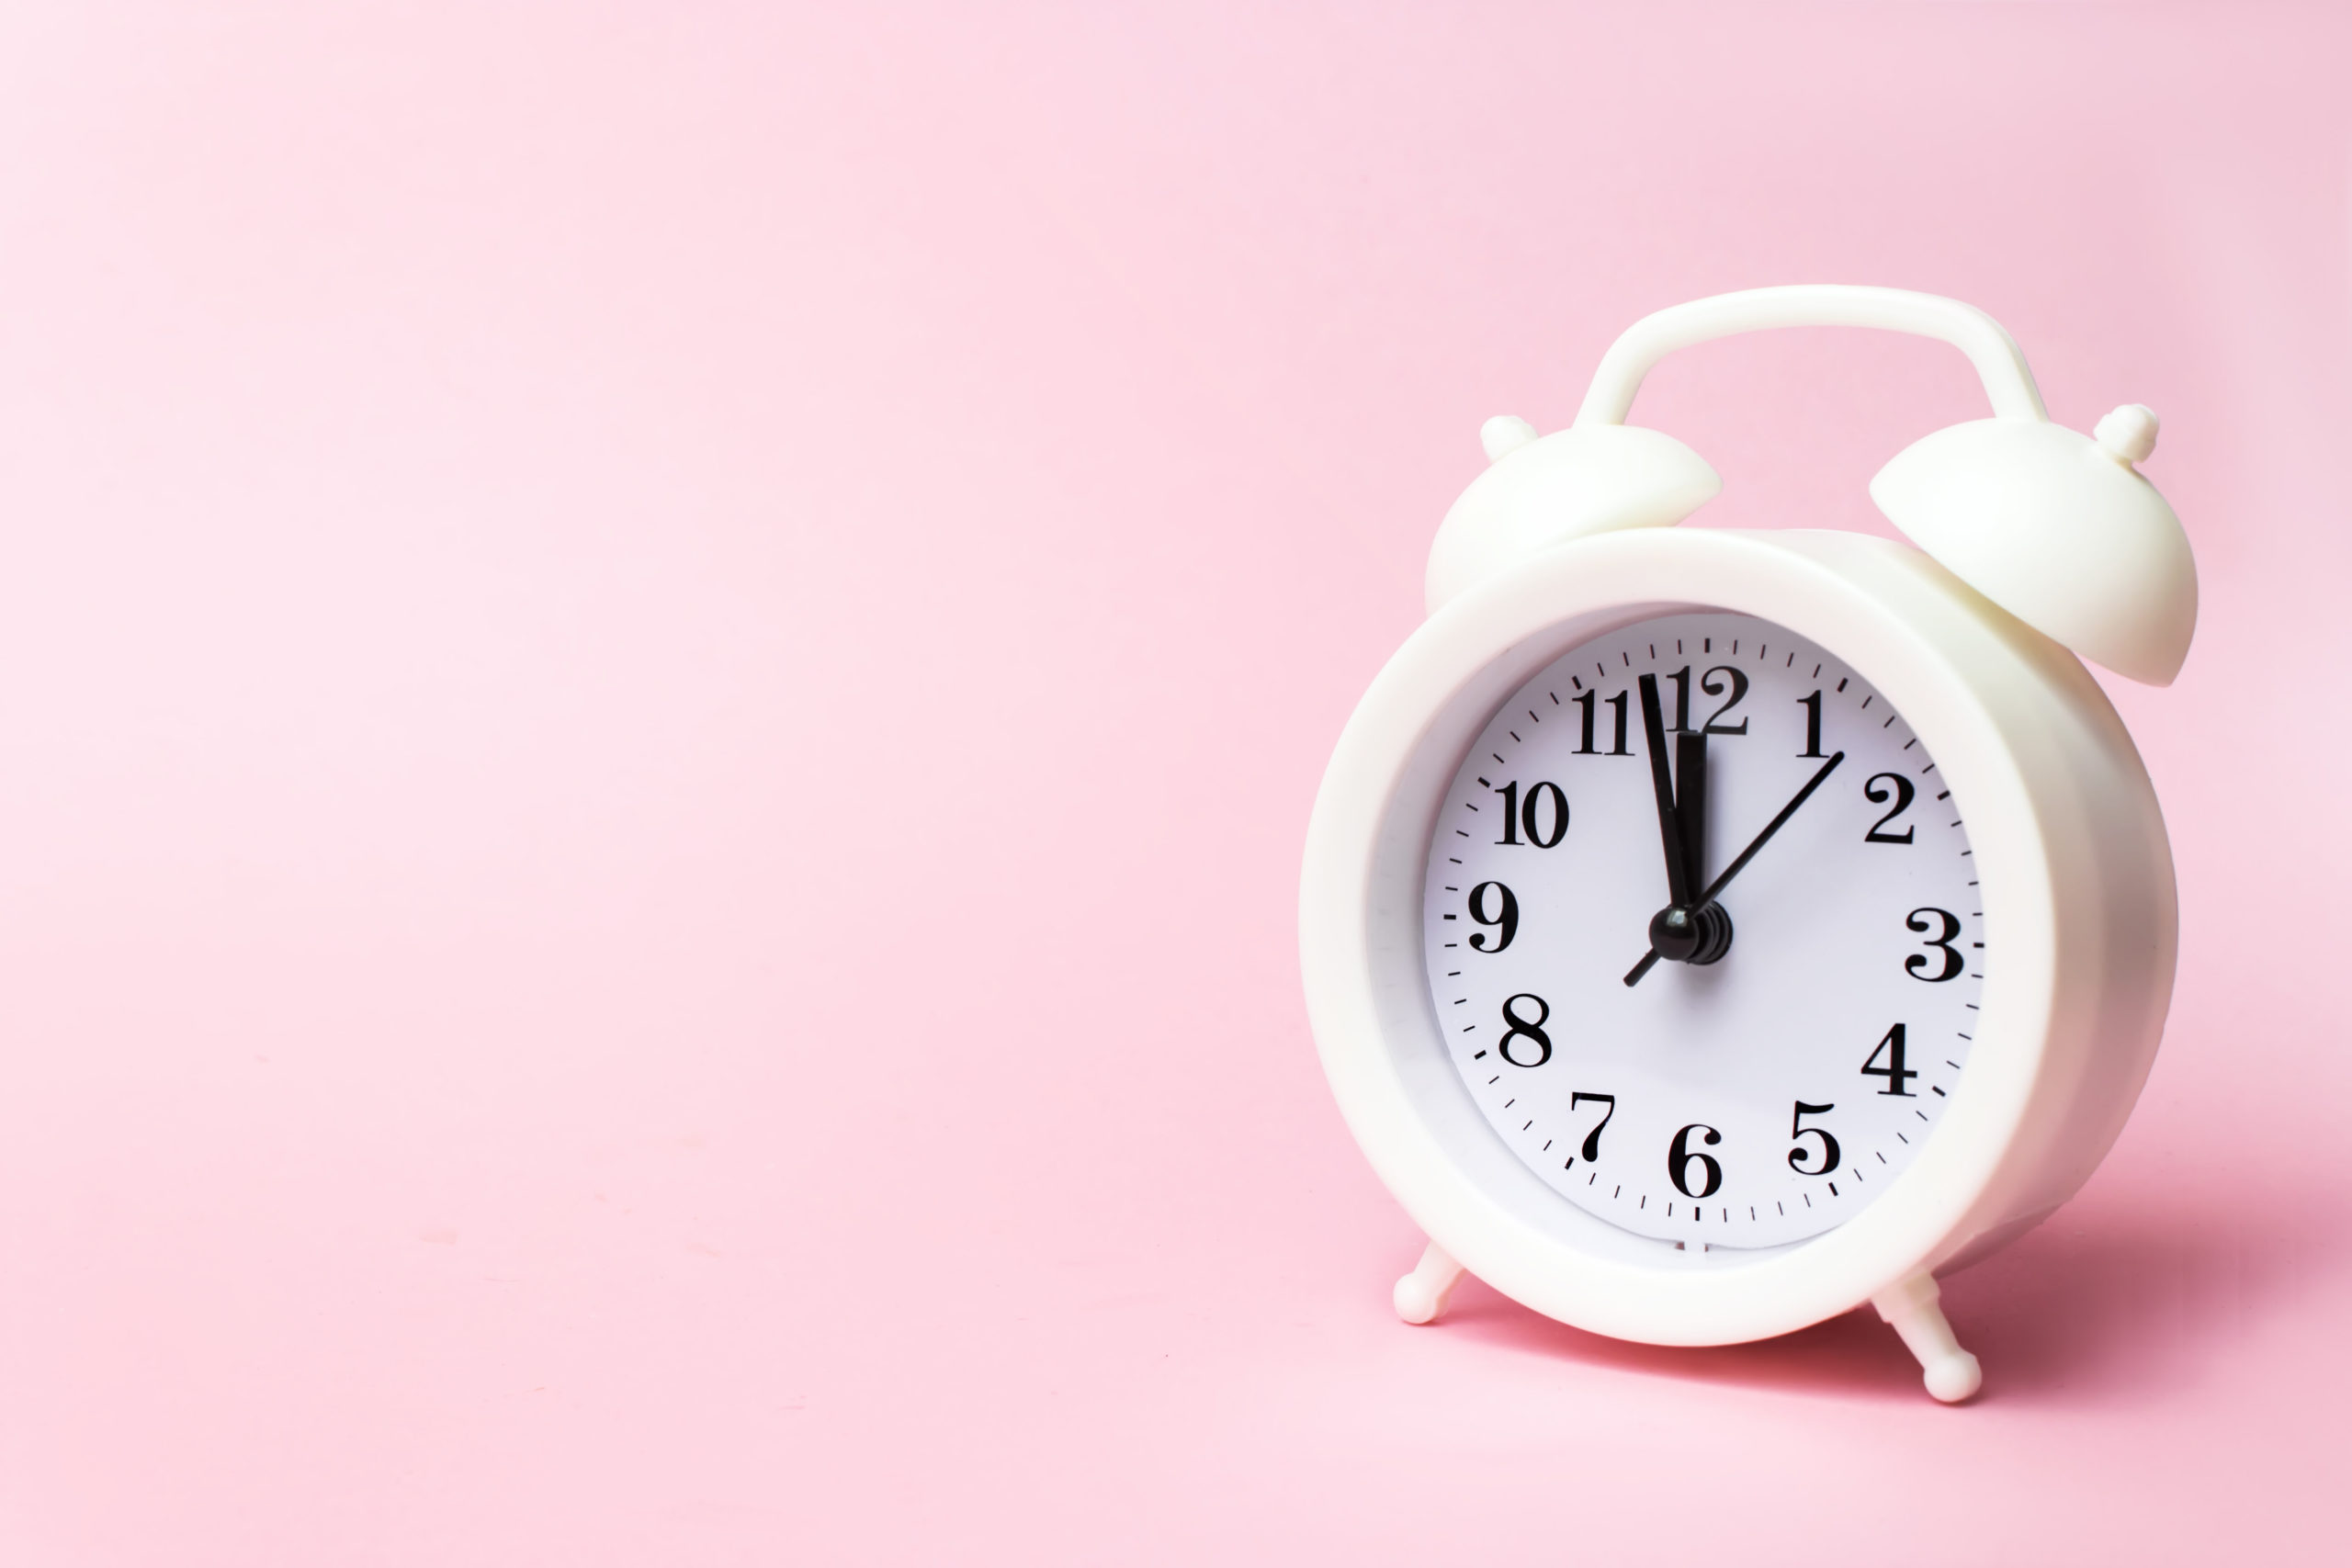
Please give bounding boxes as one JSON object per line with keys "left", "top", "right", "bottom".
{"left": 1576, "top": 282, "right": 2049, "bottom": 425}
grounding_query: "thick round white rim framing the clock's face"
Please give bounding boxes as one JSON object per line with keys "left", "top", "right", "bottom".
{"left": 1301, "top": 529, "right": 2072, "bottom": 1345}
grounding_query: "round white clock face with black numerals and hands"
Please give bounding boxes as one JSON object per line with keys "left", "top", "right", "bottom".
{"left": 1423, "top": 614, "right": 1987, "bottom": 1248}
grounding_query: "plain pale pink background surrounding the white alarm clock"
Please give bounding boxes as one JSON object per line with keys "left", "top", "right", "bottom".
{"left": 0, "top": 3, "right": 2352, "bottom": 1568}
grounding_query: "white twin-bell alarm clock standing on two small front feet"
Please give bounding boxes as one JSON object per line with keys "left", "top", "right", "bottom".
{"left": 1301, "top": 287, "right": 2197, "bottom": 1401}
